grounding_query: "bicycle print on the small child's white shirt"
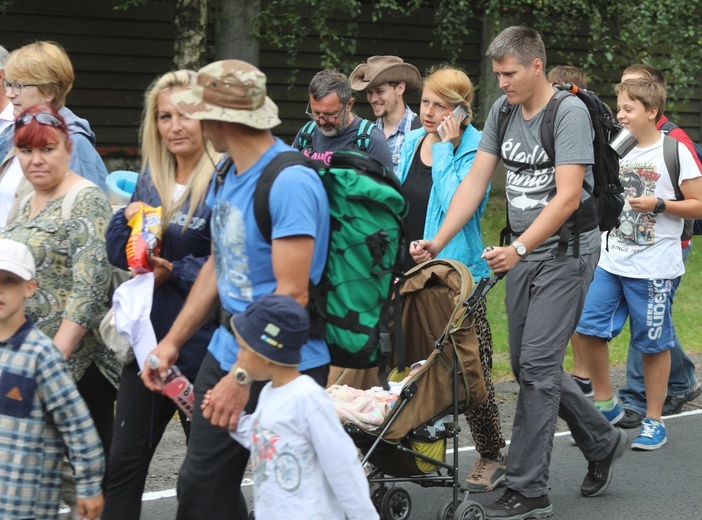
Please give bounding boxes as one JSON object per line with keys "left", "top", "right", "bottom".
{"left": 251, "top": 420, "right": 310, "bottom": 493}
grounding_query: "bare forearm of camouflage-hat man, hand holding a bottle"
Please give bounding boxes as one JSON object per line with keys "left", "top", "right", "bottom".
{"left": 141, "top": 256, "right": 218, "bottom": 392}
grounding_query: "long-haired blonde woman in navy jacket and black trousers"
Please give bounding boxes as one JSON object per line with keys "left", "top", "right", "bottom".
{"left": 102, "top": 70, "right": 219, "bottom": 520}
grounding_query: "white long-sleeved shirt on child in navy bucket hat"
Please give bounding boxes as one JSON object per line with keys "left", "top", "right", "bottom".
{"left": 231, "top": 375, "right": 378, "bottom": 520}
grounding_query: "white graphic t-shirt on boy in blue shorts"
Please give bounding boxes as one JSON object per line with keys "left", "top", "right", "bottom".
{"left": 599, "top": 133, "right": 700, "bottom": 279}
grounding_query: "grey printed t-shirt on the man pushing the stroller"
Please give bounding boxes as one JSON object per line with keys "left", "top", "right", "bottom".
{"left": 478, "top": 93, "right": 600, "bottom": 261}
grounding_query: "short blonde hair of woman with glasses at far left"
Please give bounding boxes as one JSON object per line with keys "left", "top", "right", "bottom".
{"left": 5, "top": 42, "right": 75, "bottom": 110}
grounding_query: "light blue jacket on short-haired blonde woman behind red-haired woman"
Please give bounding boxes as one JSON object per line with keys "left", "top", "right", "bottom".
{"left": 0, "top": 107, "right": 107, "bottom": 193}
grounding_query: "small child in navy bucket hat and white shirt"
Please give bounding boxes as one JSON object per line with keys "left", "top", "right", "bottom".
{"left": 210, "top": 294, "right": 378, "bottom": 520}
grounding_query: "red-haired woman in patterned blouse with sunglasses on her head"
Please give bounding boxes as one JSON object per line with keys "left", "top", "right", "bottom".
{"left": 3, "top": 105, "right": 119, "bottom": 458}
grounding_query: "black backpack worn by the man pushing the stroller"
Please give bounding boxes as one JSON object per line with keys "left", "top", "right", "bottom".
{"left": 497, "top": 83, "right": 624, "bottom": 256}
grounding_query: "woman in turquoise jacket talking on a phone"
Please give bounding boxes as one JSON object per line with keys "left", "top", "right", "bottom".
{"left": 397, "top": 66, "right": 507, "bottom": 492}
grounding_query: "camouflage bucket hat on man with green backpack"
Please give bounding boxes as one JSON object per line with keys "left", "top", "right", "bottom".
{"left": 171, "top": 60, "right": 280, "bottom": 130}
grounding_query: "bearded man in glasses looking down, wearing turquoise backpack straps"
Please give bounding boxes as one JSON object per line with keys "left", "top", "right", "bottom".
{"left": 293, "top": 69, "right": 393, "bottom": 170}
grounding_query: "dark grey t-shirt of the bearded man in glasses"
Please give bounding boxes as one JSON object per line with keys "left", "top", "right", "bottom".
{"left": 292, "top": 115, "right": 393, "bottom": 171}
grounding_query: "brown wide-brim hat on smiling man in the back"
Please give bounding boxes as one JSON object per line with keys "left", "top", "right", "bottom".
{"left": 349, "top": 56, "right": 422, "bottom": 94}
